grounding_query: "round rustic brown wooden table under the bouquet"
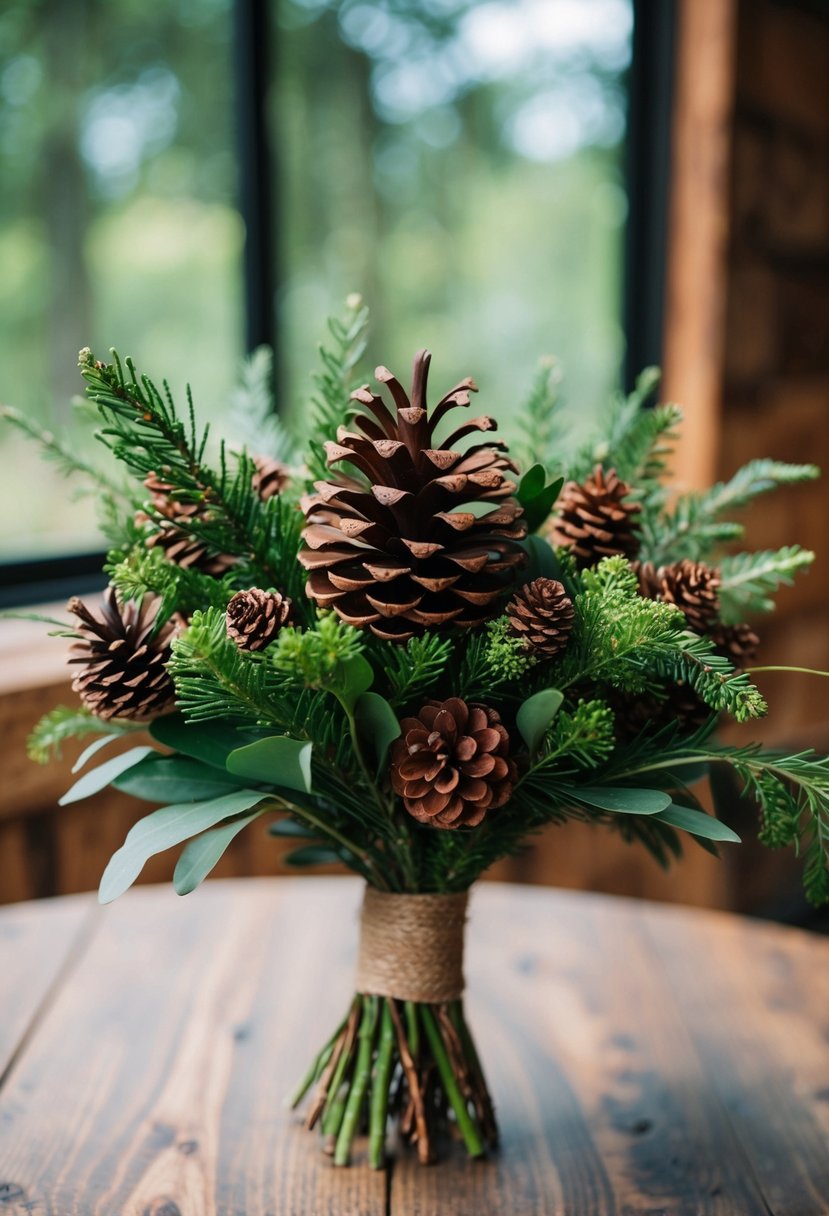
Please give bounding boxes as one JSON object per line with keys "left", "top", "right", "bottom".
{"left": 0, "top": 878, "right": 829, "bottom": 1216}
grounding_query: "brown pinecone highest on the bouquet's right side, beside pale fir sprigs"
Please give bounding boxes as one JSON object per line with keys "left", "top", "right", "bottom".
{"left": 553, "top": 465, "right": 639, "bottom": 568}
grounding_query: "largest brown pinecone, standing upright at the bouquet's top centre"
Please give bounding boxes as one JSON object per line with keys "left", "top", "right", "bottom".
{"left": 299, "top": 350, "right": 526, "bottom": 641}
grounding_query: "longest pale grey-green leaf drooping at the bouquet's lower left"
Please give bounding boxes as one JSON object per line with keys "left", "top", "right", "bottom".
{"left": 98, "top": 789, "right": 267, "bottom": 903}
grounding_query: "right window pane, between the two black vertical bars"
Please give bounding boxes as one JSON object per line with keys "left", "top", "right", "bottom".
{"left": 272, "top": 0, "right": 632, "bottom": 447}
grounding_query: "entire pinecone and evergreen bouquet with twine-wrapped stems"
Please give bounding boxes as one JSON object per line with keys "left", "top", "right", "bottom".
{"left": 6, "top": 299, "right": 829, "bottom": 1166}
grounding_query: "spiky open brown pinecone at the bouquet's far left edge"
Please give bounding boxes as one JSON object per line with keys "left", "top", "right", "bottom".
{"left": 68, "top": 587, "right": 176, "bottom": 721}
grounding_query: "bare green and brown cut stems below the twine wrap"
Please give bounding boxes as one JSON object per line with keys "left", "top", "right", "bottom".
{"left": 292, "top": 993, "right": 497, "bottom": 1170}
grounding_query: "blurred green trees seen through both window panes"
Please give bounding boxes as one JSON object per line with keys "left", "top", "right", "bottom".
{"left": 0, "top": 0, "right": 632, "bottom": 558}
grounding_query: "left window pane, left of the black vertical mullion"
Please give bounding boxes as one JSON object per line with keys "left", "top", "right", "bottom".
{"left": 0, "top": 0, "right": 242, "bottom": 559}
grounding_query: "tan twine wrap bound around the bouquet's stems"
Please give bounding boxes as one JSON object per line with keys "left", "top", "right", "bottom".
{"left": 356, "top": 886, "right": 468, "bottom": 1004}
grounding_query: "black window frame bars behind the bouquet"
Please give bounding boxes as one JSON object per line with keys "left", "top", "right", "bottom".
{"left": 0, "top": 0, "right": 677, "bottom": 609}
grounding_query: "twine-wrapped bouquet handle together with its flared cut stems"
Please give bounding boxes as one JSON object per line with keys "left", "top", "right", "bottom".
{"left": 293, "top": 886, "right": 497, "bottom": 1169}
